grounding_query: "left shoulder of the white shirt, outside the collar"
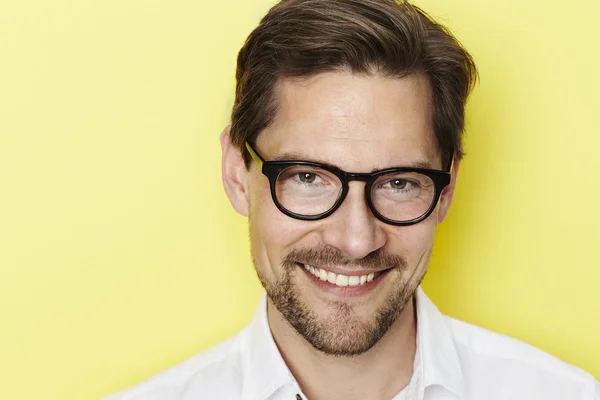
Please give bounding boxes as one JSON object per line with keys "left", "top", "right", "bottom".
{"left": 104, "top": 331, "right": 243, "bottom": 400}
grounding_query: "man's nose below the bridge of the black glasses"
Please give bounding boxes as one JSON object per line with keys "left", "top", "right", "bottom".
{"left": 322, "top": 182, "right": 386, "bottom": 259}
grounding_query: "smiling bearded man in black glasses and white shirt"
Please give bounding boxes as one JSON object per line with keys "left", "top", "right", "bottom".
{"left": 109, "top": 0, "right": 600, "bottom": 400}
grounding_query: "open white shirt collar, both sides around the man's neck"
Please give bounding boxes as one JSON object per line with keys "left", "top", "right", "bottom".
{"left": 241, "top": 287, "right": 466, "bottom": 400}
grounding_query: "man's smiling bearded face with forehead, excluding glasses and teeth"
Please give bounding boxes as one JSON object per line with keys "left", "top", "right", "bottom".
{"left": 227, "top": 72, "right": 453, "bottom": 355}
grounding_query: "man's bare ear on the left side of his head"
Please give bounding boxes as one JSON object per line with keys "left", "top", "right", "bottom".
{"left": 220, "top": 125, "right": 248, "bottom": 216}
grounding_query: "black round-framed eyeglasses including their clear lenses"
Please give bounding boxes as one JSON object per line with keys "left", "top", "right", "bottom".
{"left": 246, "top": 142, "right": 452, "bottom": 226}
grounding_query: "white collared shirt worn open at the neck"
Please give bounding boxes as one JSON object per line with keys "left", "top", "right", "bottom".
{"left": 105, "top": 288, "right": 600, "bottom": 400}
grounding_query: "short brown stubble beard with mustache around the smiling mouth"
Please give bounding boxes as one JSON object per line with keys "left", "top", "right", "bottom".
{"left": 254, "top": 247, "right": 422, "bottom": 357}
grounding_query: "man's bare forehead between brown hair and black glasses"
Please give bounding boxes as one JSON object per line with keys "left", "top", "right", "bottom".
{"left": 257, "top": 72, "right": 440, "bottom": 172}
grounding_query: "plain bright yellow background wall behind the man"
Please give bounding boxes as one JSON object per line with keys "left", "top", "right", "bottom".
{"left": 0, "top": 0, "right": 600, "bottom": 400}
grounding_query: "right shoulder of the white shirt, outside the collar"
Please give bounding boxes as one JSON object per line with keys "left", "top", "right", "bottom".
{"left": 444, "top": 316, "right": 600, "bottom": 400}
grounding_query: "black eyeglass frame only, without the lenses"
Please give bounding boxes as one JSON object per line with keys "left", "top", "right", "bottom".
{"left": 245, "top": 142, "right": 454, "bottom": 226}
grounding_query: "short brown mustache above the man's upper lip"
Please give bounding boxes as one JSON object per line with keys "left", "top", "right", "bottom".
{"left": 281, "top": 246, "right": 408, "bottom": 270}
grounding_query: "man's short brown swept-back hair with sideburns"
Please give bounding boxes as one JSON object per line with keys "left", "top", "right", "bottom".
{"left": 231, "top": 0, "right": 477, "bottom": 165}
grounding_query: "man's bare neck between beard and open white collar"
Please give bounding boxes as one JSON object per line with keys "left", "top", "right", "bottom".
{"left": 267, "top": 297, "right": 417, "bottom": 400}
